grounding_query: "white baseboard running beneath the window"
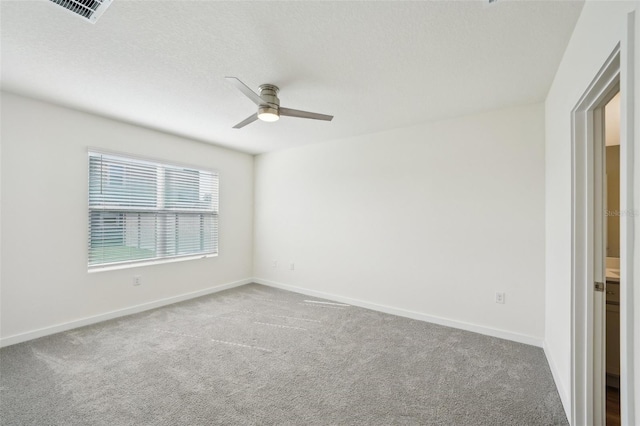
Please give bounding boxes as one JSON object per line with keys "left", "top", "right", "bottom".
{"left": 0, "top": 278, "right": 254, "bottom": 347}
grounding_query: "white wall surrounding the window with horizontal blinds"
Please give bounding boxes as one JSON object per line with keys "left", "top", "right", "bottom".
{"left": 1, "top": 93, "right": 253, "bottom": 342}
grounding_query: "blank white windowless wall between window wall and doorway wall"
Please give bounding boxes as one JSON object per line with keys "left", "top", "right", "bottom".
{"left": 254, "top": 104, "right": 544, "bottom": 344}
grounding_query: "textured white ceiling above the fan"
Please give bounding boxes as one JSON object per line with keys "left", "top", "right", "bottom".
{"left": 1, "top": 0, "right": 583, "bottom": 153}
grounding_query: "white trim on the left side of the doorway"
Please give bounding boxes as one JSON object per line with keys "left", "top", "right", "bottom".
{"left": 571, "top": 46, "right": 620, "bottom": 425}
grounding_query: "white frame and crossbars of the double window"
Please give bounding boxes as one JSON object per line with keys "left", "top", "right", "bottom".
{"left": 85, "top": 147, "right": 220, "bottom": 273}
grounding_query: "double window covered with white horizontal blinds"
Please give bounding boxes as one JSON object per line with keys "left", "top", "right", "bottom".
{"left": 89, "top": 152, "right": 218, "bottom": 269}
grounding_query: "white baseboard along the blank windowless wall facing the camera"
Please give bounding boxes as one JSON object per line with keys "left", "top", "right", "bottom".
{"left": 253, "top": 278, "right": 542, "bottom": 347}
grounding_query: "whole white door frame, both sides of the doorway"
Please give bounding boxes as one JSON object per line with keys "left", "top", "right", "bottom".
{"left": 571, "top": 12, "right": 636, "bottom": 425}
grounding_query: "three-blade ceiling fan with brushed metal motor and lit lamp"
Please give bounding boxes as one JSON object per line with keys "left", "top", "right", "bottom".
{"left": 225, "top": 77, "right": 333, "bottom": 129}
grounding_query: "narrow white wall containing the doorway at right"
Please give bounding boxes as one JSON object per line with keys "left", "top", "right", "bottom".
{"left": 545, "top": 1, "right": 640, "bottom": 420}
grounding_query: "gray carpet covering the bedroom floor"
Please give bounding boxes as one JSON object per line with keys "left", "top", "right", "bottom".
{"left": 0, "top": 284, "right": 567, "bottom": 425}
